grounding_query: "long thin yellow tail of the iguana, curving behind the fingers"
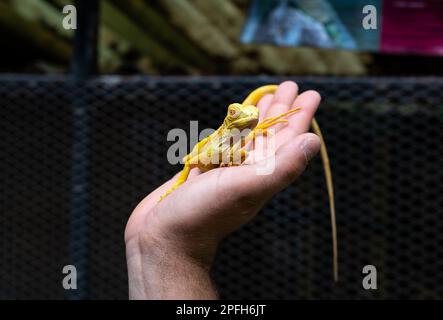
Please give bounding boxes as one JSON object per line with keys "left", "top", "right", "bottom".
{"left": 243, "top": 84, "right": 338, "bottom": 281}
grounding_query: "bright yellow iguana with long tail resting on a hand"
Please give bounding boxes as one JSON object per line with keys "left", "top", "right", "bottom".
{"left": 159, "top": 85, "right": 338, "bottom": 281}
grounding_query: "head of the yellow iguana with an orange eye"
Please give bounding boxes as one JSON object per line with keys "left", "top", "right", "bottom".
{"left": 223, "top": 103, "right": 258, "bottom": 130}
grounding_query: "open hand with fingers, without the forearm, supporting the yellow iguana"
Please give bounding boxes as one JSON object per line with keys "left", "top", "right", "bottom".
{"left": 125, "top": 81, "right": 320, "bottom": 259}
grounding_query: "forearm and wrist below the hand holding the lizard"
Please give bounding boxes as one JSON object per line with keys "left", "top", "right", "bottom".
{"left": 126, "top": 238, "right": 217, "bottom": 299}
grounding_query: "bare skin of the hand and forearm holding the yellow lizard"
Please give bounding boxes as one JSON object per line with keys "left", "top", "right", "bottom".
{"left": 125, "top": 81, "right": 320, "bottom": 299}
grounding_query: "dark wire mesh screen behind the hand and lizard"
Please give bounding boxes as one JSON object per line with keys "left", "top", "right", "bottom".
{"left": 0, "top": 77, "right": 443, "bottom": 299}
